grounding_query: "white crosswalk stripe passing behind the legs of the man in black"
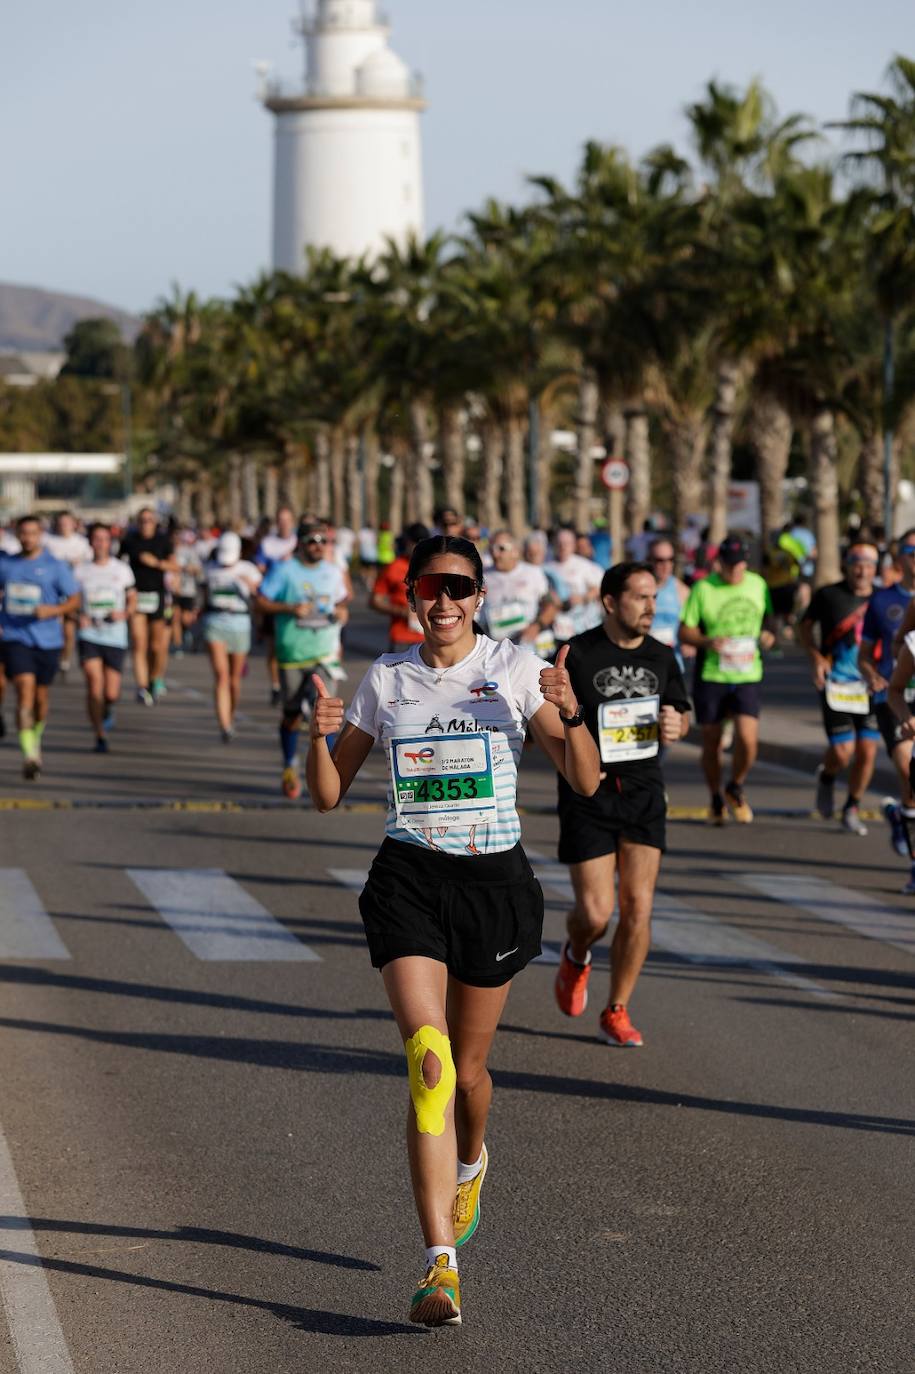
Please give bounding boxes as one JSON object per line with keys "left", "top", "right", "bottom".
{"left": 528, "top": 851, "right": 835, "bottom": 1000}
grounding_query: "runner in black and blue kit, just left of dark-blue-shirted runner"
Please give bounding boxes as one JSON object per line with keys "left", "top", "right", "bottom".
{"left": 798, "top": 540, "right": 881, "bottom": 835}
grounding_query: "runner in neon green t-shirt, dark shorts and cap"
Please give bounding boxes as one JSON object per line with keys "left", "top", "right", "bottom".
{"left": 680, "top": 534, "right": 775, "bottom": 826}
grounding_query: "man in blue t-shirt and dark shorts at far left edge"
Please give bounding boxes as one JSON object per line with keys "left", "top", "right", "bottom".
{"left": 0, "top": 515, "right": 80, "bottom": 780}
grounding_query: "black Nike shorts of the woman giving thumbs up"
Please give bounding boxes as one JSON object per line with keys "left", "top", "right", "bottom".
{"left": 359, "top": 838, "right": 543, "bottom": 988}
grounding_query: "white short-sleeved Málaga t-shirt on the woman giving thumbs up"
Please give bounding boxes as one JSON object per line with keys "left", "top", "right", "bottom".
{"left": 346, "top": 635, "right": 548, "bottom": 855}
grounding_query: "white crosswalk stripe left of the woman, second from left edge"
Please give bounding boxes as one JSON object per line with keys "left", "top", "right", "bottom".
{"left": 125, "top": 868, "right": 320, "bottom": 963}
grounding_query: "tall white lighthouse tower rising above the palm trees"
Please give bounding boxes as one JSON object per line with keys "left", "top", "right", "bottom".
{"left": 262, "top": 0, "right": 426, "bottom": 272}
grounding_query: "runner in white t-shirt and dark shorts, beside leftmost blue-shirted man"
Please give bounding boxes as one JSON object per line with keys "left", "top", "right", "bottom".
{"left": 76, "top": 521, "right": 136, "bottom": 754}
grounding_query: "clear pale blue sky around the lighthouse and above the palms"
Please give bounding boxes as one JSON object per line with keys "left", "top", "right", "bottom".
{"left": 0, "top": 0, "right": 915, "bottom": 311}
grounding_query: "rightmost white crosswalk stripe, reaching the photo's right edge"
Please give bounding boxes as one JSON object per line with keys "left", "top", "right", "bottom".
{"left": 736, "top": 872, "right": 915, "bottom": 955}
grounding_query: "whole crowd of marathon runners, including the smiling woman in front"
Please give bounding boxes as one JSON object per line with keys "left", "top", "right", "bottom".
{"left": 0, "top": 508, "right": 915, "bottom": 1326}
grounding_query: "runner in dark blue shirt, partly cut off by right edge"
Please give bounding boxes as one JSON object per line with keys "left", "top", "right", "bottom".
{"left": 857, "top": 529, "right": 915, "bottom": 859}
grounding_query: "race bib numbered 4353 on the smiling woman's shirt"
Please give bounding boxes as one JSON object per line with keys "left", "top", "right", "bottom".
{"left": 390, "top": 732, "right": 496, "bottom": 830}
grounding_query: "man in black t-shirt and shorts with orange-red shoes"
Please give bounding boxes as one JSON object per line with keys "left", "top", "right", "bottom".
{"left": 544, "top": 563, "right": 690, "bottom": 1046}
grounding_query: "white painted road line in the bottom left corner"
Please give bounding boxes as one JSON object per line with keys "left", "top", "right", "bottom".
{"left": 0, "top": 1131, "right": 73, "bottom": 1374}
